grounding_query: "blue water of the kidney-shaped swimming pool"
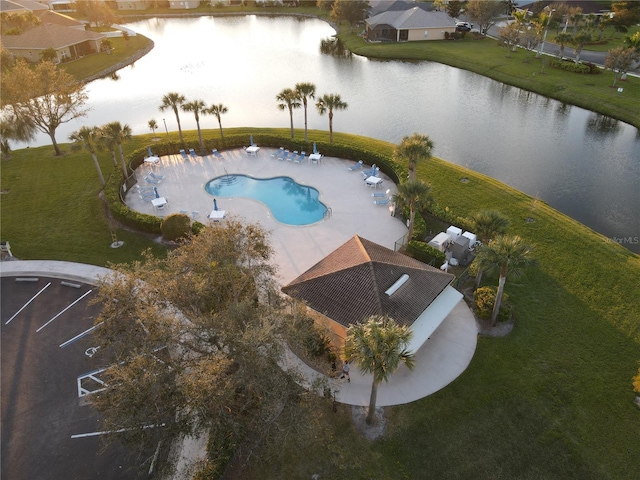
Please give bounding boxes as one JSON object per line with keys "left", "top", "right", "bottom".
{"left": 204, "top": 174, "right": 327, "bottom": 225}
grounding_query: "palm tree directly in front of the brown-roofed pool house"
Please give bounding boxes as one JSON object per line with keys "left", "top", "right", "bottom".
{"left": 344, "top": 315, "right": 414, "bottom": 425}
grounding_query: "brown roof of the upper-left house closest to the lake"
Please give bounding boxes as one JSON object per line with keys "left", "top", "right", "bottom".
{"left": 2, "top": 24, "right": 104, "bottom": 50}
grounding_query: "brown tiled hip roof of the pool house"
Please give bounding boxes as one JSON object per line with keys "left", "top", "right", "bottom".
{"left": 282, "top": 235, "right": 454, "bottom": 327}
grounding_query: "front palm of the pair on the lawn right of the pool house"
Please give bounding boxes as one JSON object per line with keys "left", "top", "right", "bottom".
{"left": 478, "top": 235, "right": 537, "bottom": 326}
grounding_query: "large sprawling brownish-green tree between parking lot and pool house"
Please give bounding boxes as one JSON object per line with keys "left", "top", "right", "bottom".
{"left": 92, "top": 219, "right": 303, "bottom": 468}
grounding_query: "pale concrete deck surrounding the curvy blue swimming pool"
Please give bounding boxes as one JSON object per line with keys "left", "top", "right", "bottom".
{"left": 131, "top": 148, "right": 407, "bottom": 285}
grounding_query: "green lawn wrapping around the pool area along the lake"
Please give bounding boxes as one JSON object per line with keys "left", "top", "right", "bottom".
{"left": 0, "top": 128, "right": 640, "bottom": 480}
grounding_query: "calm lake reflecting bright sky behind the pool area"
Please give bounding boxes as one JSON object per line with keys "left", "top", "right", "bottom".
{"left": 22, "top": 16, "right": 640, "bottom": 252}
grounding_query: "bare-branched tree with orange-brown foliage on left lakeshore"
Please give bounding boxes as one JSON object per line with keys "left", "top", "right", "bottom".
{"left": 0, "top": 61, "right": 88, "bottom": 155}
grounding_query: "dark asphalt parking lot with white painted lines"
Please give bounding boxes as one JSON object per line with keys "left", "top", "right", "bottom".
{"left": 0, "top": 277, "right": 146, "bottom": 480}
